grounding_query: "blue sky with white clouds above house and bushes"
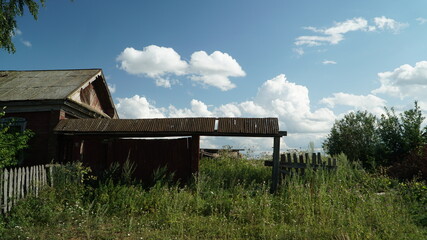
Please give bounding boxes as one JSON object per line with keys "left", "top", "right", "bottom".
{"left": 0, "top": 0, "right": 427, "bottom": 151}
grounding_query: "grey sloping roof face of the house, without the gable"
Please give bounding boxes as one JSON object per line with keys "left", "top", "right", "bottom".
{"left": 0, "top": 69, "right": 101, "bottom": 101}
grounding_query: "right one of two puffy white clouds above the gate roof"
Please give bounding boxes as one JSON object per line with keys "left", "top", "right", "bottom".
{"left": 190, "top": 51, "right": 246, "bottom": 91}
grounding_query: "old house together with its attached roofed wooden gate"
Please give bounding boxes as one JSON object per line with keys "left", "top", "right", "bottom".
{"left": 0, "top": 69, "right": 286, "bottom": 185}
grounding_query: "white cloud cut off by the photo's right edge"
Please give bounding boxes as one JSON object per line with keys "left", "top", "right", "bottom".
{"left": 372, "top": 61, "right": 427, "bottom": 101}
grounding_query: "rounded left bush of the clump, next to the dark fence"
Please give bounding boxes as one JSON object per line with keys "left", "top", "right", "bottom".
{"left": 322, "top": 111, "right": 378, "bottom": 166}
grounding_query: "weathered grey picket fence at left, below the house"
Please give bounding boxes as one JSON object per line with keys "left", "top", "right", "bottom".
{"left": 0, "top": 165, "right": 55, "bottom": 213}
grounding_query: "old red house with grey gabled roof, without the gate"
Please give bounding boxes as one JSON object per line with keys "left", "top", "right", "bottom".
{"left": 0, "top": 69, "right": 118, "bottom": 164}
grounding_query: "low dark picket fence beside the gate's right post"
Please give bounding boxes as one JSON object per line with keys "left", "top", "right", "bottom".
{"left": 264, "top": 153, "right": 337, "bottom": 174}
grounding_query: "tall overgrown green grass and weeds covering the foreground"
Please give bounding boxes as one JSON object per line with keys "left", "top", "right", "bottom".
{"left": 0, "top": 156, "right": 427, "bottom": 240}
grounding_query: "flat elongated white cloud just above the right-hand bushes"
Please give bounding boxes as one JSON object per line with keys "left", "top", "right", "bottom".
{"left": 320, "top": 92, "right": 386, "bottom": 115}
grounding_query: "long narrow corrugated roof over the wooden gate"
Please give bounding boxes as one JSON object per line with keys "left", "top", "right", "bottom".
{"left": 54, "top": 118, "right": 281, "bottom": 137}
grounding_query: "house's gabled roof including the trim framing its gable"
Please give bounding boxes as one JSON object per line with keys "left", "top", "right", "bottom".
{"left": 0, "top": 69, "right": 117, "bottom": 117}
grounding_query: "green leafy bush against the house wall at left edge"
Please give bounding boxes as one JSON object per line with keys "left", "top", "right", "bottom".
{"left": 0, "top": 112, "right": 34, "bottom": 169}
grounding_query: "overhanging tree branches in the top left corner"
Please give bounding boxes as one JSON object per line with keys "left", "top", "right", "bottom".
{"left": 0, "top": 0, "right": 45, "bottom": 53}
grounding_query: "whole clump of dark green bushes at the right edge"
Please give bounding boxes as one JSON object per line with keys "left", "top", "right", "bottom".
{"left": 323, "top": 102, "right": 427, "bottom": 172}
